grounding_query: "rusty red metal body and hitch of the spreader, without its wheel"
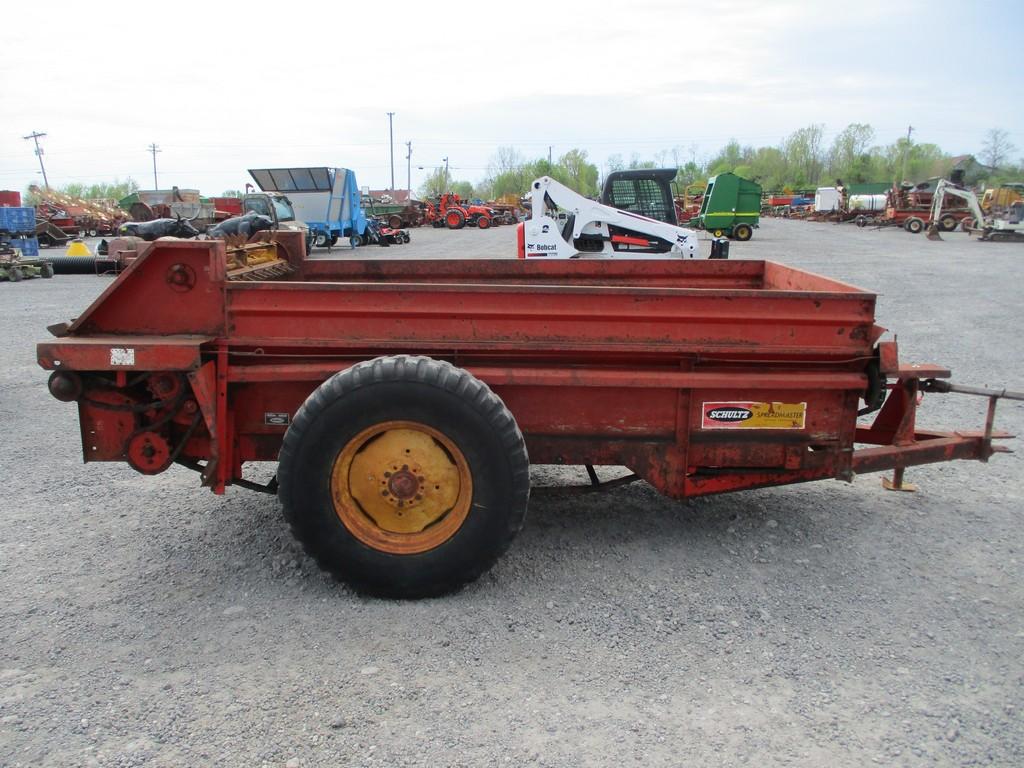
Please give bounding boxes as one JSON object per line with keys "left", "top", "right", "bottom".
{"left": 38, "top": 242, "right": 1014, "bottom": 498}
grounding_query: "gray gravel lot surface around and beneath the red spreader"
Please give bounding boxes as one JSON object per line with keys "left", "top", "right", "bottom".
{"left": 0, "top": 220, "right": 1024, "bottom": 768}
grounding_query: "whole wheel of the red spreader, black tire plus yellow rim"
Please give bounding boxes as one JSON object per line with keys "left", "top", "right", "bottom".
{"left": 278, "top": 355, "right": 529, "bottom": 598}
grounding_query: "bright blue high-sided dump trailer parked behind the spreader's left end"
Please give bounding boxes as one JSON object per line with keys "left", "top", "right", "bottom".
{"left": 246, "top": 167, "right": 367, "bottom": 247}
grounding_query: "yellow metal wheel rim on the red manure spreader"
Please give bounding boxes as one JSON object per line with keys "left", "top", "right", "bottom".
{"left": 331, "top": 421, "right": 473, "bottom": 555}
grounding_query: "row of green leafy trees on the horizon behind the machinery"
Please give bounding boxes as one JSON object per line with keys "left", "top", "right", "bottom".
{"left": 420, "top": 123, "right": 1024, "bottom": 200}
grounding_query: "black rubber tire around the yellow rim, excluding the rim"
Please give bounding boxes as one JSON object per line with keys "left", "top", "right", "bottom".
{"left": 278, "top": 355, "right": 529, "bottom": 598}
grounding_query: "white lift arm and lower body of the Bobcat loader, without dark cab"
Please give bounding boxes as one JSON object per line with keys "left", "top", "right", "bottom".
{"left": 518, "top": 176, "right": 700, "bottom": 259}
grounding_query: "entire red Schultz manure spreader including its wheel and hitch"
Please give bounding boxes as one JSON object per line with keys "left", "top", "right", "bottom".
{"left": 38, "top": 232, "right": 1024, "bottom": 597}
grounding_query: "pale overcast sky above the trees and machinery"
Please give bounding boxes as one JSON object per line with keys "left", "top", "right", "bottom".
{"left": 0, "top": 0, "right": 1024, "bottom": 195}
